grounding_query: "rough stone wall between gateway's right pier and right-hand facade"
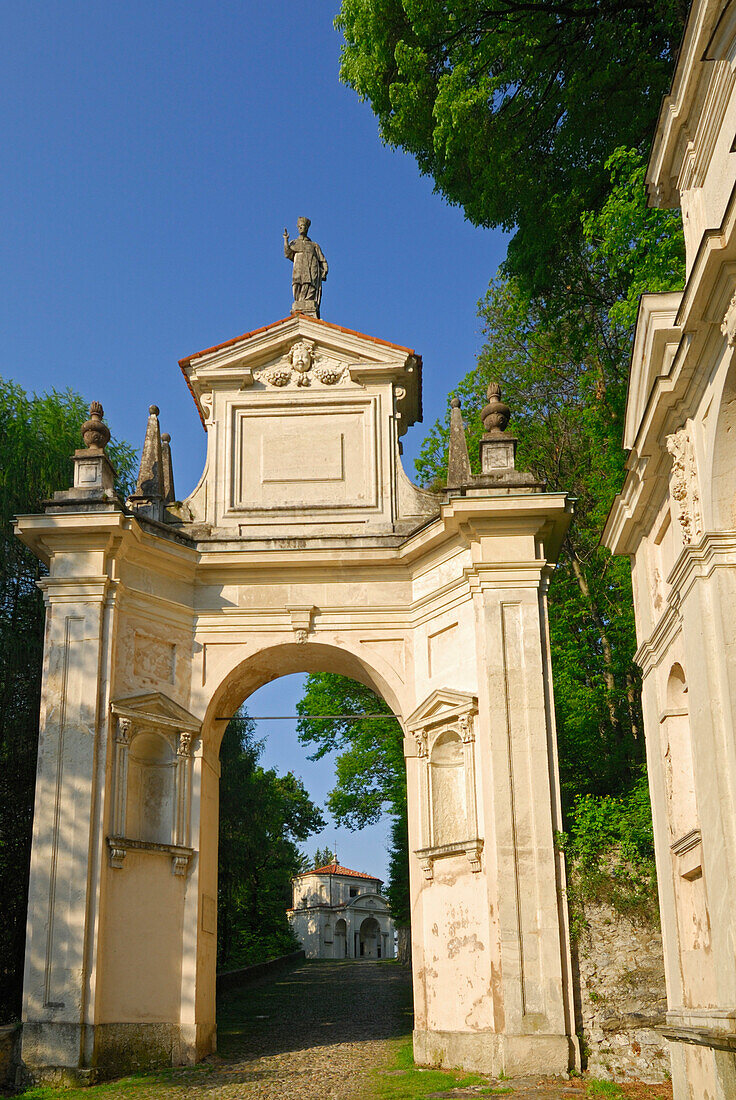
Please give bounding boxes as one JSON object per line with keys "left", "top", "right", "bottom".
{"left": 573, "top": 902, "right": 670, "bottom": 1084}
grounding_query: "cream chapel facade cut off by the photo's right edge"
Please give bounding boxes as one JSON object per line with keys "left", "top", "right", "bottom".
{"left": 603, "top": 0, "right": 736, "bottom": 1100}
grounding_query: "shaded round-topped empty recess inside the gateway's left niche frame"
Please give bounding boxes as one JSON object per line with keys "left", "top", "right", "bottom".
{"left": 125, "top": 733, "right": 176, "bottom": 844}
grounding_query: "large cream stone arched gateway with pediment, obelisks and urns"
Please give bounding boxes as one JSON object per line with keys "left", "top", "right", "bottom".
{"left": 18, "top": 312, "right": 575, "bottom": 1075}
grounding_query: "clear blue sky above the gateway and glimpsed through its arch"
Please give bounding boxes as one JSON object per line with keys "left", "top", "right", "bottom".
{"left": 0, "top": 0, "right": 505, "bottom": 873}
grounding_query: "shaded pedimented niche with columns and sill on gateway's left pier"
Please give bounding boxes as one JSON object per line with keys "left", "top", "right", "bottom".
{"left": 108, "top": 692, "right": 200, "bottom": 875}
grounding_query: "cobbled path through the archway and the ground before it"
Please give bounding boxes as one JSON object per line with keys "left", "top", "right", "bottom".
{"left": 17, "top": 961, "right": 672, "bottom": 1100}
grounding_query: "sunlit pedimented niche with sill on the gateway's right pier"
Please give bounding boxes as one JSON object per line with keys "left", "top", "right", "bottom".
{"left": 406, "top": 689, "right": 483, "bottom": 880}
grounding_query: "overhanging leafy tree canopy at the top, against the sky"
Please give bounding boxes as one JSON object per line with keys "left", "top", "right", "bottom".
{"left": 336, "top": 0, "right": 688, "bottom": 290}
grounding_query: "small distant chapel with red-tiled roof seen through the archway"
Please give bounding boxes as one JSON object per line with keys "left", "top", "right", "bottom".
{"left": 287, "top": 862, "right": 395, "bottom": 959}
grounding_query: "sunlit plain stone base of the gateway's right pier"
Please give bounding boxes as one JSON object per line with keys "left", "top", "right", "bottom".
{"left": 414, "top": 1031, "right": 580, "bottom": 1077}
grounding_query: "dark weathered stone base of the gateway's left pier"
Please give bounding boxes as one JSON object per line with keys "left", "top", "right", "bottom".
{"left": 21, "top": 1022, "right": 194, "bottom": 1085}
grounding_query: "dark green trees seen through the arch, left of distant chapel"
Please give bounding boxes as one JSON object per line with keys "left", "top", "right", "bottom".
{"left": 218, "top": 711, "right": 325, "bottom": 968}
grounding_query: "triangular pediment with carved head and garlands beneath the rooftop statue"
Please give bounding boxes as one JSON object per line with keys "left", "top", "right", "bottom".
{"left": 179, "top": 314, "right": 421, "bottom": 427}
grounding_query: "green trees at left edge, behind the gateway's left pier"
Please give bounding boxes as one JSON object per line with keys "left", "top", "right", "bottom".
{"left": 0, "top": 380, "right": 135, "bottom": 1022}
